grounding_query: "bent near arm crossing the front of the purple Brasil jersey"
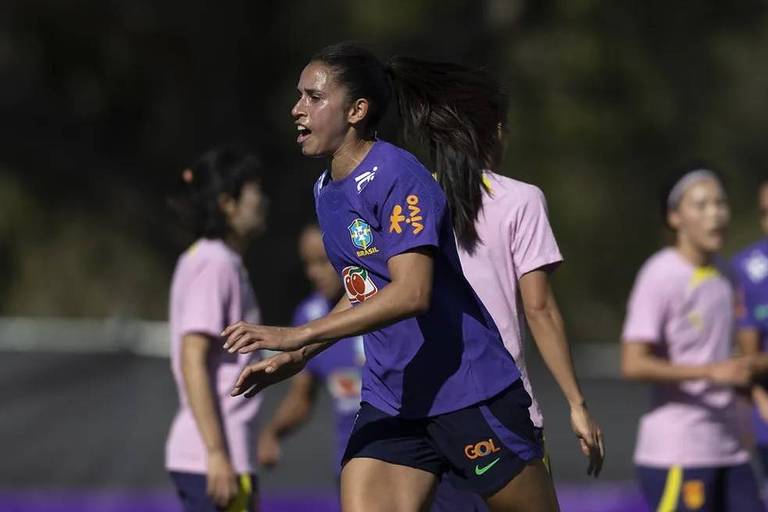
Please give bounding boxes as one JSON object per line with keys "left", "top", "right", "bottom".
{"left": 222, "top": 248, "right": 433, "bottom": 358}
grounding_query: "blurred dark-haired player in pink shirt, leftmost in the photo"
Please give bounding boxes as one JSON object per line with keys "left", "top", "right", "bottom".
{"left": 166, "top": 149, "right": 265, "bottom": 512}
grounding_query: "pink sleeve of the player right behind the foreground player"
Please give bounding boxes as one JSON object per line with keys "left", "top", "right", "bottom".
{"left": 511, "top": 187, "right": 563, "bottom": 279}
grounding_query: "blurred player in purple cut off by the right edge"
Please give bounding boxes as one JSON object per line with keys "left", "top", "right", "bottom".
{"left": 732, "top": 180, "right": 768, "bottom": 474}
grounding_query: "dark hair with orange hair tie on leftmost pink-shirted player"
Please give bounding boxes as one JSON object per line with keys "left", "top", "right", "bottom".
{"left": 168, "top": 146, "right": 262, "bottom": 238}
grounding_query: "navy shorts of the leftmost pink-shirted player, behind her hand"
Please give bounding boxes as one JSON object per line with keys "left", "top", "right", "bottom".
{"left": 170, "top": 471, "right": 259, "bottom": 512}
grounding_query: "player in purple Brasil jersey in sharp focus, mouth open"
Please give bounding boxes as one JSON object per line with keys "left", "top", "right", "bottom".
{"left": 224, "top": 44, "right": 557, "bottom": 511}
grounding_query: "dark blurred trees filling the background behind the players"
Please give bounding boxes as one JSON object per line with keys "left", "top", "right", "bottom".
{"left": 0, "top": 0, "right": 768, "bottom": 341}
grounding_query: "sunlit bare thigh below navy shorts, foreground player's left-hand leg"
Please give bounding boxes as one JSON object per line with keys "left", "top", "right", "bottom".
{"left": 341, "top": 457, "right": 437, "bottom": 512}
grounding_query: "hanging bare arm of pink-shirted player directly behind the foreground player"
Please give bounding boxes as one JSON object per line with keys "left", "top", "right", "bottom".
{"left": 519, "top": 270, "right": 605, "bottom": 476}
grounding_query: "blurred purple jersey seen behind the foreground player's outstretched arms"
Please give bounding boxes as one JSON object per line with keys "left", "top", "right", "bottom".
{"left": 293, "top": 293, "right": 365, "bottom": 468}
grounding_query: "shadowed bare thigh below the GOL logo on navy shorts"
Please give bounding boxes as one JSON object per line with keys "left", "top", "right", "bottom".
{"left": 486, "top": 459, "right": 559, "bottom": 512}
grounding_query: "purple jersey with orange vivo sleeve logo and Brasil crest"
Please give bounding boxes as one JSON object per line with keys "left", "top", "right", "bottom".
{"left": 315, "top": 141, "right": 520, "bottom": 418}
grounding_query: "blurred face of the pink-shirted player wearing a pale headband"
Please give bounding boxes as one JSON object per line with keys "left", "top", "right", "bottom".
{"left": 669, "top": 179, "right": 730, "bottom": 254}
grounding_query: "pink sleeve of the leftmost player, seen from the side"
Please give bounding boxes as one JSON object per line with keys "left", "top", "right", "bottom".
{"left": 179, "top": 260, "right": 240, "bottom": 338}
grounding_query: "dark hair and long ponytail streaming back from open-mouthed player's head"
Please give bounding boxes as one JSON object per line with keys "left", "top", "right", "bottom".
{"left": 312, "top": 43, "right": 507, "bottom": 252}
